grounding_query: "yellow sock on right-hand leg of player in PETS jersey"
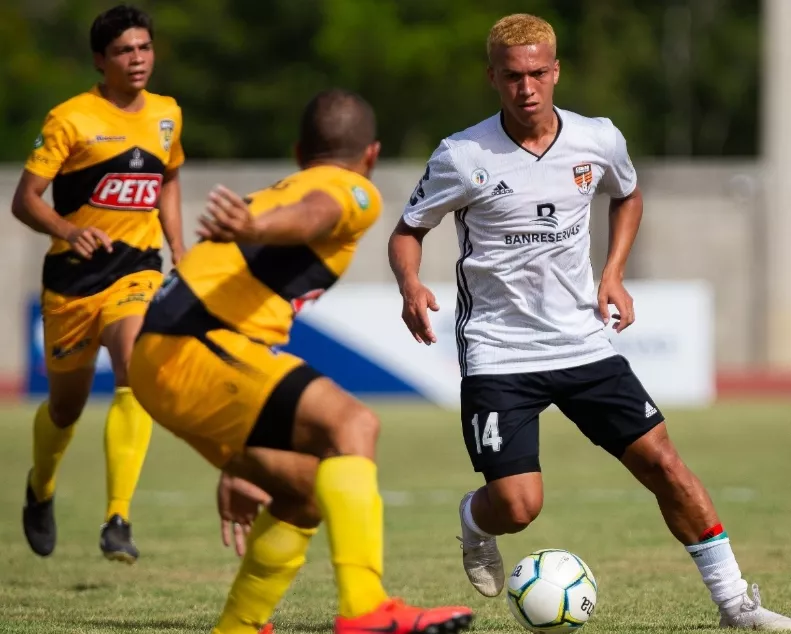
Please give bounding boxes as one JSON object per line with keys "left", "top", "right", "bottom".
{"left": 104, "top": 387, "right": 152, "bottom": 521}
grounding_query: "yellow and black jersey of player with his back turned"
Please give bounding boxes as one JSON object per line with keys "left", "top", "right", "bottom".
{"left": 143, "top": 166, "right": 382, "bottom": 346}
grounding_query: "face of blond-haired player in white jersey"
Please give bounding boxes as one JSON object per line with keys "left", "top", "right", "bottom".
{"left": 489, "top": 44, "right": 560, "bottom": 125}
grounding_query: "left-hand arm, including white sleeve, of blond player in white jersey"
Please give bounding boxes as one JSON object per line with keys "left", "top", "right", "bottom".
{"left": 388, "top": 141, "right": 468, "bottom": 345}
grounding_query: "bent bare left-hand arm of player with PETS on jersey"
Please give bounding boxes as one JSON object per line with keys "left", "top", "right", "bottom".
{"left": 11, "top": 170, "right": 113, "bottom": 259}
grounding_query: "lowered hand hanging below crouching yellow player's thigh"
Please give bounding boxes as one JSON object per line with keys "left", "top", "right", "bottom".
{"left": 217, "top": 471, "right": 272, "bottom": 557}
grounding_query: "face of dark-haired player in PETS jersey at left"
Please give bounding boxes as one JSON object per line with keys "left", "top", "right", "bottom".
{"left": 95, "top": 28, "right": 154, "bottom": 93}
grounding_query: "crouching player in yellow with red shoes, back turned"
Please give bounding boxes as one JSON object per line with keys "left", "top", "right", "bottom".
{"left": 129, "top": 90, "right": 472, "bottom": 634}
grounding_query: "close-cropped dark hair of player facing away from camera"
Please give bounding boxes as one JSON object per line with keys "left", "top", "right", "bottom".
{"left": 299, "top": 88, "right": 376, "bottom": 163}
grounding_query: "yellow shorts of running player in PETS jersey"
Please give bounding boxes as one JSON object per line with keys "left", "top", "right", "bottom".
{"left": 41, "top": 271, "right": 162, "bottom": 373}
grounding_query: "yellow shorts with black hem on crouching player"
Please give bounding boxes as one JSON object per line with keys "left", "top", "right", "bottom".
{"left": 129, "top": 330, "right": 321, "bottom": 468}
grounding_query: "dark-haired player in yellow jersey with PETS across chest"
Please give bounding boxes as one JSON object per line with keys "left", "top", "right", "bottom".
{"left": 12, "top": 6, "right": 184, "bottom": 563}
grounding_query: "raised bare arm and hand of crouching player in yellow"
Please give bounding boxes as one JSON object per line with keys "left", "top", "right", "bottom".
{"left": 198, "top": 186, "right": 344, "bottom": 245}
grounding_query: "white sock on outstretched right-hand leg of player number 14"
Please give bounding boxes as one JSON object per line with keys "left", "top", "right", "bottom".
{"left": 686, "top": 533, "right": 747, "bottom": 608}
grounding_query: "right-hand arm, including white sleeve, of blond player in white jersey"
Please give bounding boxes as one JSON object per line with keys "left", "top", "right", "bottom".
{"left": 598, "top": 122, "right": 643, "bottom": 332}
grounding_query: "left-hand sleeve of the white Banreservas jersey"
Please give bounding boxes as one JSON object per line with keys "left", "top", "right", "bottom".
{"left": 402, "top": 141, "right": 468, "bottom": 229}
